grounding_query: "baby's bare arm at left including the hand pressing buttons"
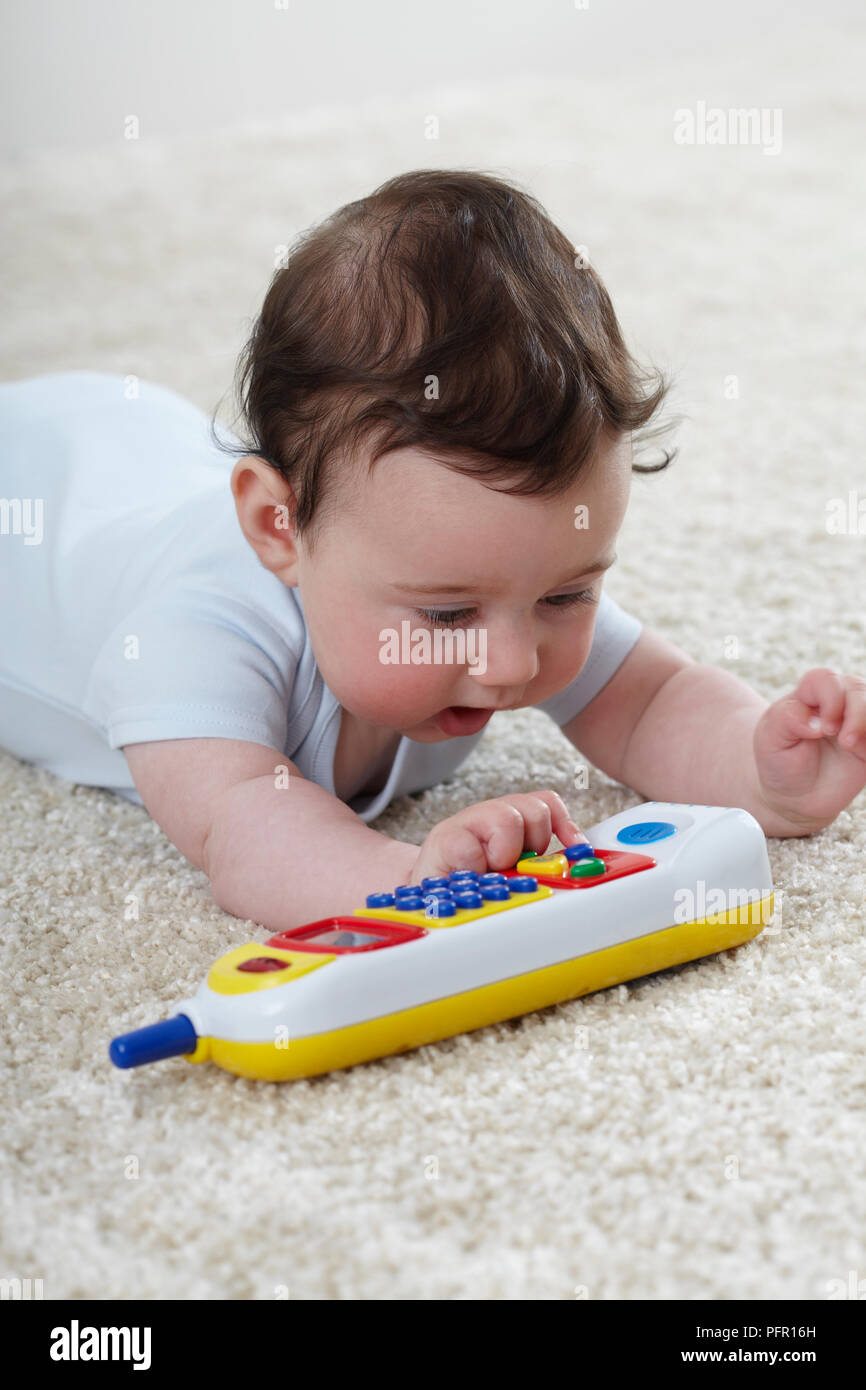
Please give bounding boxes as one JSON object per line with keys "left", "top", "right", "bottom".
{"left": 124, "top": 738, "right": 584, "bottom": 931}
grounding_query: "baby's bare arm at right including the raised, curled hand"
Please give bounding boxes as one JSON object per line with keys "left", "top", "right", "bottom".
{"left": 564, "top": 631, "right": 866, "bottom": 837}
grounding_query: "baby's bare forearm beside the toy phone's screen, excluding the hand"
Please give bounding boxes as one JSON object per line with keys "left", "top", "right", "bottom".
{"left": 124, "top": 738, "right": 420, "bottom": 931}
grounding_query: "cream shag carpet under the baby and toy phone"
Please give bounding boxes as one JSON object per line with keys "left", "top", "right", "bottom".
{"left": 0, "top": 17, "right": 866, "bottom": 1300}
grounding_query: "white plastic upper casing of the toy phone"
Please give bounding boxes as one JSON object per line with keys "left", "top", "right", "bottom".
{"left": 178, "top": 802, "right": 773, "bottom": 1043}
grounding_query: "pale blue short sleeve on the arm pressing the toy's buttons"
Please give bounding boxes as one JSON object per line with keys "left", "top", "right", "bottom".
{"left": 83, "top": 589, "right": 297, "bottom": 752}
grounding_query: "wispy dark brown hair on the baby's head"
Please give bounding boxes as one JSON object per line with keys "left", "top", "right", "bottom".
{"left": 211, "top": 170, "right": 677, "bottom": 546}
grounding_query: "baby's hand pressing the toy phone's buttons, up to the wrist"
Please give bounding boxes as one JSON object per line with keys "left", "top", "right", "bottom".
{"left": 407, "top": 790, "right": 587, "bottom": 884}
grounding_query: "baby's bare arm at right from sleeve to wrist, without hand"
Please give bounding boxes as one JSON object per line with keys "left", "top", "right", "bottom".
{"left": 563, "top": 628, "right": 833, "bottom": 837}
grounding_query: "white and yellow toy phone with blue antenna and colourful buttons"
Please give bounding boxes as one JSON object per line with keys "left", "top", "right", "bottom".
{"left": 108, "top": 802, "right": 773, "bottom": 1081}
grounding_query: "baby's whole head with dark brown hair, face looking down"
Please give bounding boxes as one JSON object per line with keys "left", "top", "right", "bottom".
{"left": 218, "top": 170, "right": 670, "bottom": 742}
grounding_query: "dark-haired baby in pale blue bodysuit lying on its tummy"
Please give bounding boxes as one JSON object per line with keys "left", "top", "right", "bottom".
{"left": 0, "top": 170, "right": 866, "bottom": 931}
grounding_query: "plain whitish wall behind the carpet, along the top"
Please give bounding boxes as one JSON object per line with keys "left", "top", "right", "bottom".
{"left": 0, "top": 0, "right": 862, "bottom": 156}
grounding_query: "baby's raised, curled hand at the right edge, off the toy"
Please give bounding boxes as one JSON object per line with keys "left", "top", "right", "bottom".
{"left": 753, "top": 666, "right": 866, "bottom": 830}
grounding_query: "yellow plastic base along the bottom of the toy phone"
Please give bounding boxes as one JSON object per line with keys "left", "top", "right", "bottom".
{"left": 186, "top": 894, "right": 773, "bottom": 1081}
